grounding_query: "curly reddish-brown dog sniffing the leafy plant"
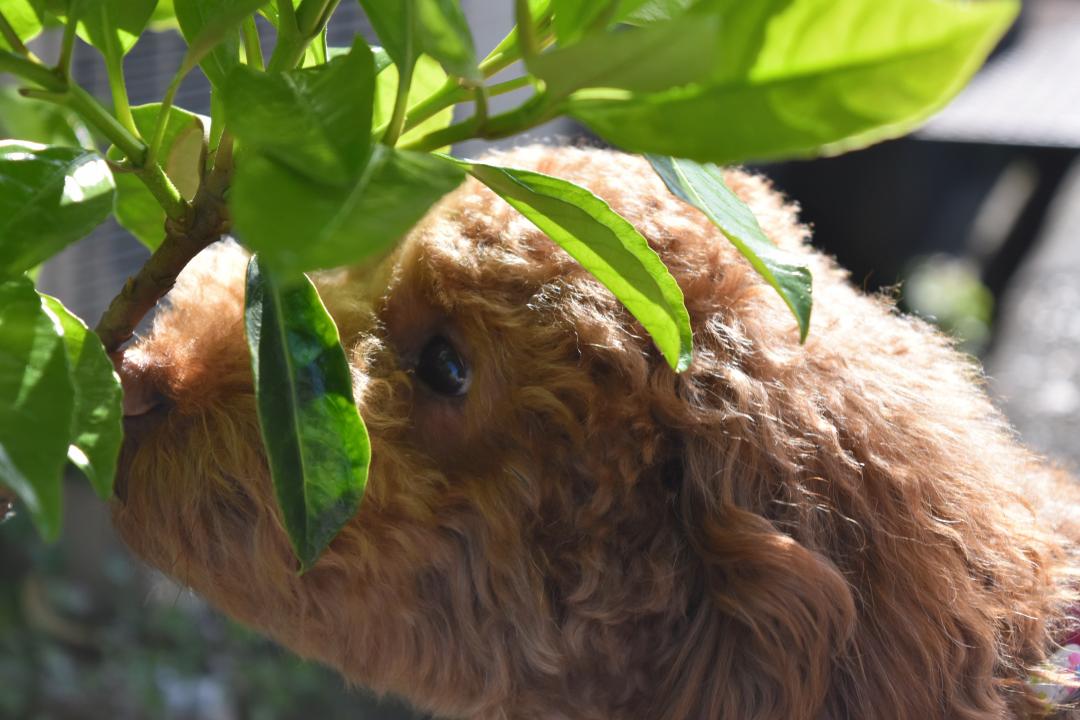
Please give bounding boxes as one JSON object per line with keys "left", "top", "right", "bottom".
{"left": 114, "top": 146, "right": 1080, "bottom": 720}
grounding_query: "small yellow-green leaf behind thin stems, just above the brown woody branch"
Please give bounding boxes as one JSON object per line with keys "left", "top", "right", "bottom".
{"left": 107, "top": 103, "right": 208, "bottom": 250}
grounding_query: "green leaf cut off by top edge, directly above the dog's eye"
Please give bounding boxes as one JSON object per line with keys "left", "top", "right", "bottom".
{"left": 360, "top": 0, "right": 483, "bottom": 81}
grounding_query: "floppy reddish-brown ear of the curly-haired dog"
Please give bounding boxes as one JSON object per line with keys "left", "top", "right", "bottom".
{"left": 653, "top": 437, "right": 855, "bottom": 720}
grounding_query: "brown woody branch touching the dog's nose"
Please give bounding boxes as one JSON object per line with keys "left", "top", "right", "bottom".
{"left": 94, "top": 135, "right": 232, "bottom": 353}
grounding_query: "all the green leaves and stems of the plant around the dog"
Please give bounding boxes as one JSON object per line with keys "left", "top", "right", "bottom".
{"left": 0, "top": 0, "right": 1018, "bottom": 568}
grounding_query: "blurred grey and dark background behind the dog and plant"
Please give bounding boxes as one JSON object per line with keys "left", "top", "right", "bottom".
{"left": 0, "top": 0, "right": 1080, "bottom": 720}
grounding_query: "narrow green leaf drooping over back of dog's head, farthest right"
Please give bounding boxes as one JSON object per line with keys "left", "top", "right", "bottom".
{"left": 648, "top": 155, "right": 813, "bottom": 342}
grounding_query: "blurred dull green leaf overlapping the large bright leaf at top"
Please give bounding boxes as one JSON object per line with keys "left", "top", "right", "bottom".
{"left": 529, "top": 15, "right": 719, "bottom": 99}
